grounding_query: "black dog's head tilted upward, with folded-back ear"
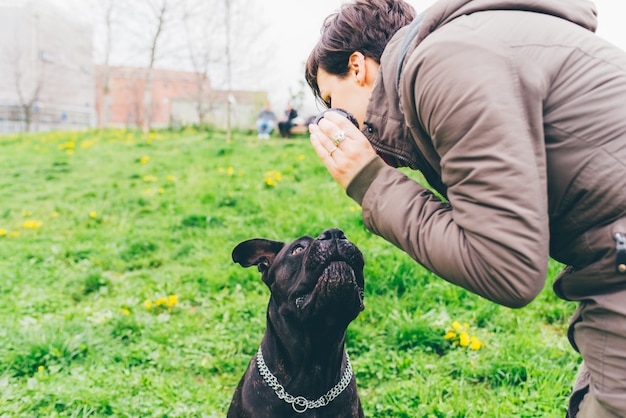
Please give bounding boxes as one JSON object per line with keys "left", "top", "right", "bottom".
{"left": 232, "top": 229, "right": 364, "bottom": 327}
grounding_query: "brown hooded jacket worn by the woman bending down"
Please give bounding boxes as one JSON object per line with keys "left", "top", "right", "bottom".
{"left": 347, "top": 0, "right": 626, "bottom": 307}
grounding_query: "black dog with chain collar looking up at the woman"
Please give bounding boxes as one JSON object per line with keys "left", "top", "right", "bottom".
{"left": 228, "top": 229, "right": 364, "bottom": 418}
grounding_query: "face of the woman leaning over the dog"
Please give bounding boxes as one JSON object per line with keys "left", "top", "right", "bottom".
{"left": 317, "top": 63, "right": 373, "bottom": 126}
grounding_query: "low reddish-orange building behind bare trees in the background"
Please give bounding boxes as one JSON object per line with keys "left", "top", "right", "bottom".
{"left": 96, "top": 65, "right": 267, "bottom": 129}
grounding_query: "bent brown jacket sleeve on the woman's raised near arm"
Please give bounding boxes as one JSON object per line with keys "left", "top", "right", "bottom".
{"left": 348, "top": 34, "right": 549, "bottom": 307}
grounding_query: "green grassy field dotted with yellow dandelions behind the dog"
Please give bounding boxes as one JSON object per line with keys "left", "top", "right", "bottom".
{"left": 0, "top": 130, "right": 579, "bottom": 417}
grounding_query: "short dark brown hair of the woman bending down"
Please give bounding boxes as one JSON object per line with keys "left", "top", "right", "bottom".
{"left": 304, "top": 0, "right": 415, "bottom": 106}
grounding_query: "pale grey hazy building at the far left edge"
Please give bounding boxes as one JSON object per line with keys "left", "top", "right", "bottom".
{"left": 0, "top": 0, "right": 95, "bottom": 132}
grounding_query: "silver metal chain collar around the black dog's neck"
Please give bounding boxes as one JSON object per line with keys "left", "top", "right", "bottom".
{"left": 256, "top": 347, "right": 352, "bottom": 414}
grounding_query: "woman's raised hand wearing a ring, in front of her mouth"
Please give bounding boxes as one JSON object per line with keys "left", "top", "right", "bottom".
{"left": 309, "top": 112, "right": 376, "bottom": 190}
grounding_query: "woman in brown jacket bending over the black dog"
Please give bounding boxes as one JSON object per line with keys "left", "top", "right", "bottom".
{"left": 306, "top": 0, "right": 626, "bottom": 418}
